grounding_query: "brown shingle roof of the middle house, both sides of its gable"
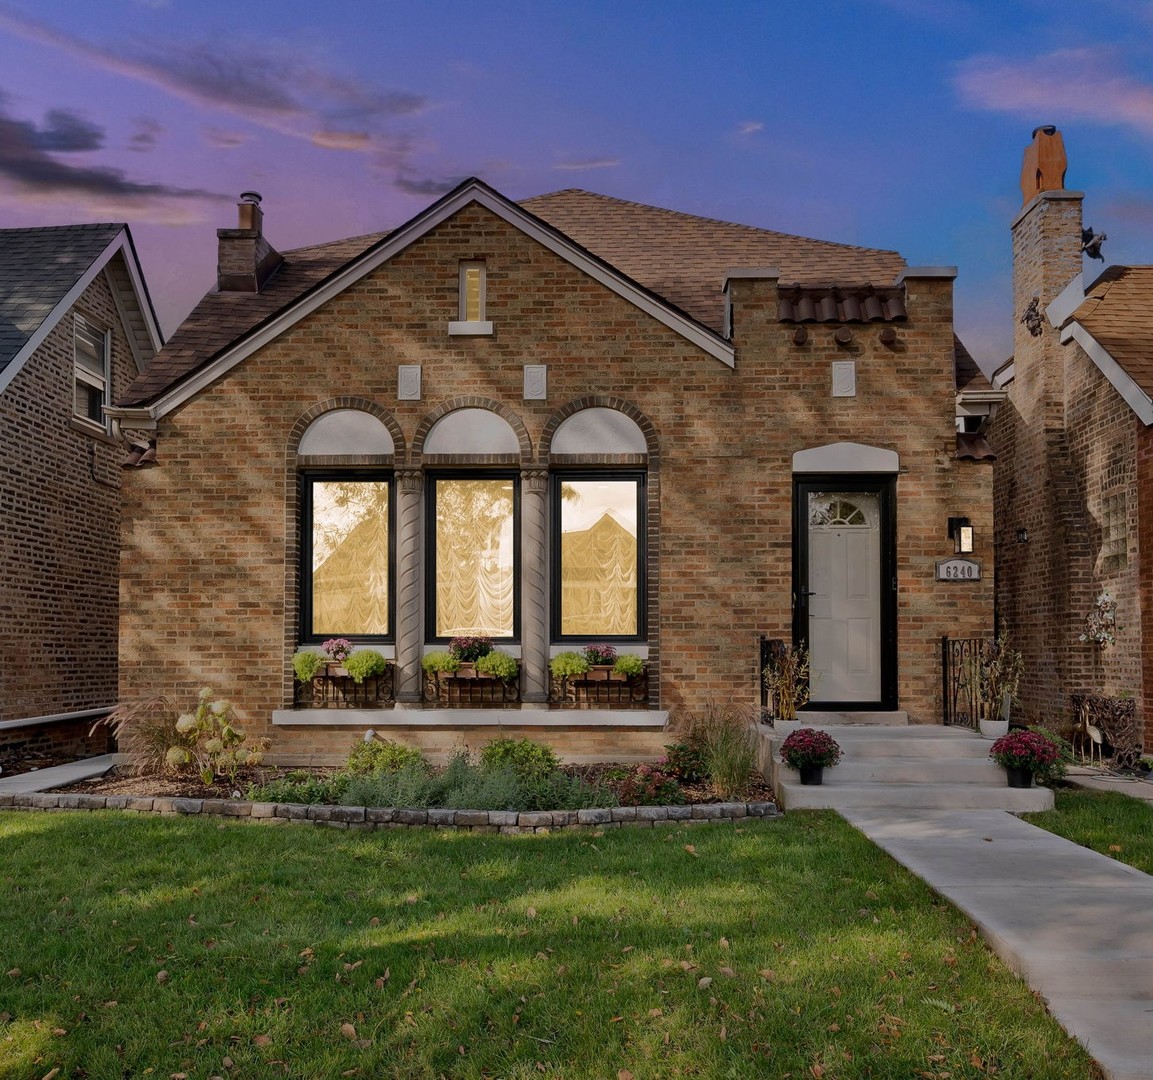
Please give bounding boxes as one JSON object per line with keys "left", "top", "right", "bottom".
{"left": 119, "top": 189, "right": 905, "bottom": 406}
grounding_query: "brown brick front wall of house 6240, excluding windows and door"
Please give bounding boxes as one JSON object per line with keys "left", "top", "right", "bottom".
{"left": 121, "top": 206, "right": 992, "bottom": 753}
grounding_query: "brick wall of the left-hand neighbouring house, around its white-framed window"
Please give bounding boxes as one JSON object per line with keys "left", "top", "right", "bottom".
{"left": 0, "top": 269, "right": 135, "bottom": 720}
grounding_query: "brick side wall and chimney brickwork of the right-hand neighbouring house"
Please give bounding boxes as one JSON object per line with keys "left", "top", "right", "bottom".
{"left": 992, "top": 192, "right": 1153, "bottom": 746}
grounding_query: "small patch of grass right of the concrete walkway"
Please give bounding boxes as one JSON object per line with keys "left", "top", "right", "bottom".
{"left": 1023, "top": 787, "right": 1153, "bottom": 874}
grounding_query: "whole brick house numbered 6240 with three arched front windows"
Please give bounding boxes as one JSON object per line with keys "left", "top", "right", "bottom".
{"left": 114, "top": 180, "right": 997, "bottom": 760}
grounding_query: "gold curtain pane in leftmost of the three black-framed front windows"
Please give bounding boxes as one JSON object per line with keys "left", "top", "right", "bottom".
{"left": 312, "top": 481, "right": 389, "bottom": 635}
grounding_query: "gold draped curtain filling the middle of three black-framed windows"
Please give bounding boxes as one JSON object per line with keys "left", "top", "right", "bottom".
{"left": 436, "top": 479, "right": 514, "bottom": 637}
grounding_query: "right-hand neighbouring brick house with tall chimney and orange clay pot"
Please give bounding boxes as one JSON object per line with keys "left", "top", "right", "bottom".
{"left": 990, "top": 128, "right": 1153, "bottom": 746}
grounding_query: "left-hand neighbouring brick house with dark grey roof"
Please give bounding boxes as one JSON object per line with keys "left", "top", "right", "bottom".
{"left": 0, "top": 225, "right": 161, "bottom": 742}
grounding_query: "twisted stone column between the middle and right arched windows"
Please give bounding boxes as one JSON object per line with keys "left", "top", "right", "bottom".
{"left": 520, "top": 469, "right": 549, "bottom": 704}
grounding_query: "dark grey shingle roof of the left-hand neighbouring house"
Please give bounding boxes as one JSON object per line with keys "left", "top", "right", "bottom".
{"left": 0, "top": 224, "right": 125, "bottom": 371}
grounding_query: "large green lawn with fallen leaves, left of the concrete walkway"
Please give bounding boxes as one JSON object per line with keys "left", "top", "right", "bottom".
{"left": 0, "top": 811, "right": 1094, "bottom": 1080}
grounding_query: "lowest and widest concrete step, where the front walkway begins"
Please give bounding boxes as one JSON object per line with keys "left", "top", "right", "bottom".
{"left": 774, "top": 779, "right": 1053, "bottom": 814}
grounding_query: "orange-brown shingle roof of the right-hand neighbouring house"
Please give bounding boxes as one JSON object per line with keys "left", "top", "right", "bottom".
{"left": 1070, "top": 266, "right": 1153, "bottom": 398}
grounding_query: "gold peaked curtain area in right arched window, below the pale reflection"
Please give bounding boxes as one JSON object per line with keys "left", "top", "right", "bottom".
{"left": 560, "top": 509, "right": 638, "bottom": 636}
